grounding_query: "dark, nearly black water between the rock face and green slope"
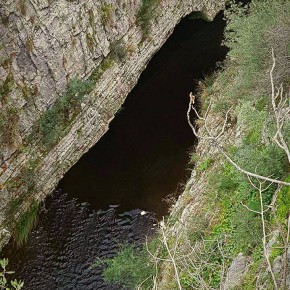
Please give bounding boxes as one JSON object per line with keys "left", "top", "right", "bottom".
{"left": 3, "top": 14, "right": 226, "bottom": 290}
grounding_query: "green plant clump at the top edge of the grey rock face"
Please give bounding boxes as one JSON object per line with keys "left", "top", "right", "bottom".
{"left": 136, "top": 0, "right": 160, "bottom": 39}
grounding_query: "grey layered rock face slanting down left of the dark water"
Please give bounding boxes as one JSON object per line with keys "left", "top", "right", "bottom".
{"left": 0, "top": 0, "right": 225, "bottom": 249}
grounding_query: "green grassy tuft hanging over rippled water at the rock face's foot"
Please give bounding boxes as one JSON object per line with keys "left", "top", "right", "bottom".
{"left": 14, "top": 201, "right": 39, "bottom": 245}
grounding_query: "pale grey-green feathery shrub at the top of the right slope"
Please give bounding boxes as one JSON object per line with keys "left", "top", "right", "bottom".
{"left": 218, "top": 0, "right": 290, "bottom": 101}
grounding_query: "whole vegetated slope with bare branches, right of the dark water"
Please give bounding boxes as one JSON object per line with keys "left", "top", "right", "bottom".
{"left": 100, "top": 0, "right": 290, "bottom": 289}
